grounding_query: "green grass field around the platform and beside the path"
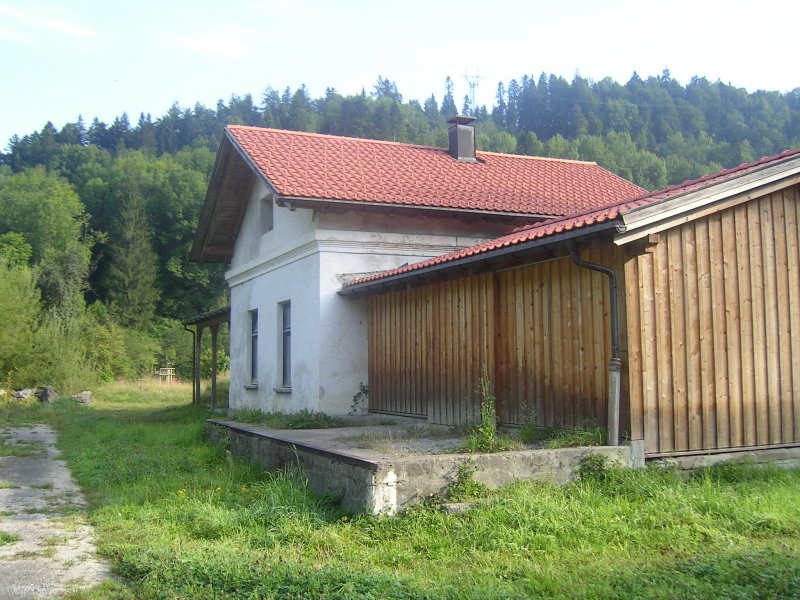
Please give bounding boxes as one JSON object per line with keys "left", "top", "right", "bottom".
{"left": 0, "top": 385, "right": 800, "bottom": 599}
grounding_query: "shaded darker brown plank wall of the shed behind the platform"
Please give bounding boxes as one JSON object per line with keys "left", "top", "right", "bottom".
{"left": 369, "top": 246, "right": 628, "bottom": 430}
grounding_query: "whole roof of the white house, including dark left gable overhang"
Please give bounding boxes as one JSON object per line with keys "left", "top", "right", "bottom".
{"left": 191, "top": 125, "right": 643, "bottom": 260}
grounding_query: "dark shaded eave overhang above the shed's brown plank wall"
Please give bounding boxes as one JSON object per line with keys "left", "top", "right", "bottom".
{"left": 338, "top": 219, "right": 622, "bottom": 297}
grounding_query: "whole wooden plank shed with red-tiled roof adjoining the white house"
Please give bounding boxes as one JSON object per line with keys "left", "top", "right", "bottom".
{"left": 341, "top": 150, "right": 800, "bottom": 457}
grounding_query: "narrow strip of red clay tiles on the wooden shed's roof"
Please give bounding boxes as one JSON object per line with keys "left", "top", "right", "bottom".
{"left": 344, "top": 148, "right": 800, "bottom": 289}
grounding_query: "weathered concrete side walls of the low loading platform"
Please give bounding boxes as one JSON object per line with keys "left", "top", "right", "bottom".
{"left": 208, "top": 421, "right": 644, "bottom": 515}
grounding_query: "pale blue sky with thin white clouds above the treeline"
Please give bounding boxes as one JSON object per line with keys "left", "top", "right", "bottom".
{"left": 0, "top": 0, "right": 800, "bottom": 147}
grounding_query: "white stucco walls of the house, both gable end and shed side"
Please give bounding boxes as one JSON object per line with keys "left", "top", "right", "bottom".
{"left": 226, "top": 184, "right": 504, "bottom": 414}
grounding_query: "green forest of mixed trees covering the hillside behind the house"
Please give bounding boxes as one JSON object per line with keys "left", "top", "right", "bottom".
{"left": 0, "top": 70, "right": 800, "bottom": 392}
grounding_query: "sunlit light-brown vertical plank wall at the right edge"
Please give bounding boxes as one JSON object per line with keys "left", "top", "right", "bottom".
{"left": 625, "top": 186, "right": 800, "bottom": 454}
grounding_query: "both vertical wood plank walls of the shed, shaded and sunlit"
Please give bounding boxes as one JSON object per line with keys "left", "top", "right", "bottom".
{"left": 368, "top": 186, "right": 800, "bottom": 453}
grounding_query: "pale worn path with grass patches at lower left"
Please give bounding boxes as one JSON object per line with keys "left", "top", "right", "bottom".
{"left": 0, "top": 425, "right": 110, "bottom": 600}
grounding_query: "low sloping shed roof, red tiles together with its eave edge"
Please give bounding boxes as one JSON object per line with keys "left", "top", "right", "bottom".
{"left": 342, "top": 148, "right": 800, "bottom": 294}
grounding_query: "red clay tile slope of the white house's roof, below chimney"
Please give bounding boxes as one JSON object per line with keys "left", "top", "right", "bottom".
{"left": 228, "top": 125, "right": 643, "bottom": 215}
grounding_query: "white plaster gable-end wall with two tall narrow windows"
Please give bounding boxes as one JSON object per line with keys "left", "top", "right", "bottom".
{"left": 226, "top": 183, "right": 320, "bottom": 412}
